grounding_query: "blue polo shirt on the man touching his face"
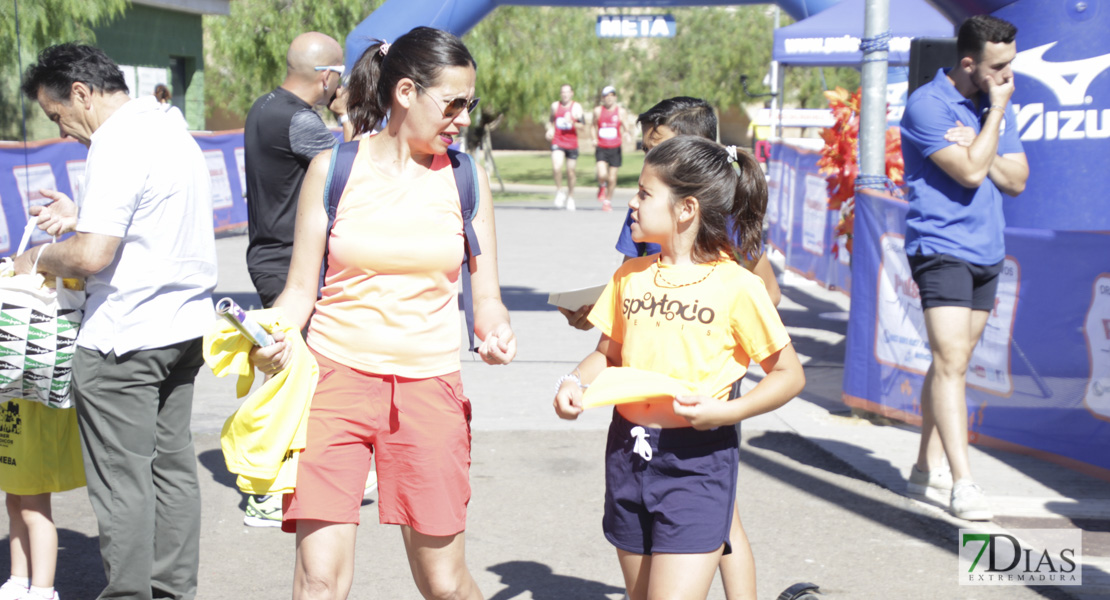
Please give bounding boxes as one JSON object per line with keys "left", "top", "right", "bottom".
{"left": 901, "top": 69, "right": 1025, "bottom": 265}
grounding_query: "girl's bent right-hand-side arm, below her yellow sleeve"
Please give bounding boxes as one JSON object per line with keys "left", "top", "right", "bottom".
{"left": 675, "top": 344, "right": 806, "bottom": 429}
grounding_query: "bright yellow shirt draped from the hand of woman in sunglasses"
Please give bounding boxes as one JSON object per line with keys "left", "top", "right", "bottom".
{"left": 204, "top": 308, "right": 320, "bottom": 495}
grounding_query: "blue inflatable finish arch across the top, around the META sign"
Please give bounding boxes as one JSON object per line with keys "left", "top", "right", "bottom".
{"left": 346, "top": 0, "right": 839, "bottom": 69}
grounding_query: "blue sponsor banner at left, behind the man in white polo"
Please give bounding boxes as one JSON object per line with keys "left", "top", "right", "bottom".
{"left": 0, "top": 131, "right": 342, "bottom": 254}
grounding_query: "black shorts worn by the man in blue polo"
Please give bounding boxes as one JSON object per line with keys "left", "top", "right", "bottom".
{"left": 907, "top": 254, "right": 1005, "bottom": 311}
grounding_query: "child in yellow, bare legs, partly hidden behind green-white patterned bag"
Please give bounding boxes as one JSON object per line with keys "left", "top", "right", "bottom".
{"left": 0, "top": 399, "right": 84, "bottom": 600}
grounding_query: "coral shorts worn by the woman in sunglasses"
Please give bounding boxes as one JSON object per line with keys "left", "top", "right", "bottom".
{"left": 282, "top": 353, "right": 471, "bottom": 536}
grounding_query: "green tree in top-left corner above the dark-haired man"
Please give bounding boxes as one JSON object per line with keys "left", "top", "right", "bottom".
{"left": 0, "top": 0, "right": 131, "bottom": 140}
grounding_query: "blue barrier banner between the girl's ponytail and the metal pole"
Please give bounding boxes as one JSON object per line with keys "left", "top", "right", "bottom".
{"left": 767, "top": 143, "right": 851, "bottom": 292}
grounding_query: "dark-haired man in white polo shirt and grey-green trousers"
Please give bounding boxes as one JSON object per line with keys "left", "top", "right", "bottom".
{"left": 16, "top": 43, "right": 216, "bottom": 599}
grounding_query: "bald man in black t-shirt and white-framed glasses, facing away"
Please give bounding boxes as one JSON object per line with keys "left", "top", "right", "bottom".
{"left": 243, "top": 32, "right": 343, "bottom": 308}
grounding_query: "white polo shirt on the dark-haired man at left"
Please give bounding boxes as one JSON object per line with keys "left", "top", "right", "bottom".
{"left": 77, "top": 95, "right": 216, "bottom": 355}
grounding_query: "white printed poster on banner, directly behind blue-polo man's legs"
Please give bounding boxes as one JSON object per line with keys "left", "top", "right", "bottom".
{"left": 875, "top": 233, "right": 1020, "bottom": 396}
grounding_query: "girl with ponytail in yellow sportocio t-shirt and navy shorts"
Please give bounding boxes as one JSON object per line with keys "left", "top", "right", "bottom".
{"left": 554, "top": 135, "right": 805, "bottom": 600}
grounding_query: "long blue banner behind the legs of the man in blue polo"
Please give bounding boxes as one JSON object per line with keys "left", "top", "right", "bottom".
{"left": 844, "top": 193, "right": 1110, "bottom": 478}
